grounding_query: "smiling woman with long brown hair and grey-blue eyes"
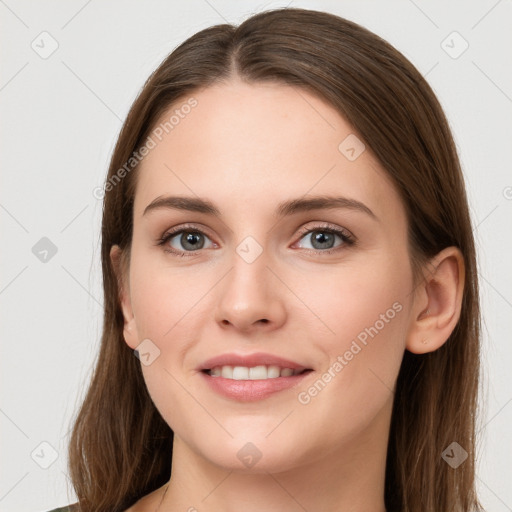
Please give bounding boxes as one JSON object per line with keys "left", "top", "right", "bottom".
{"left": 51, "top": 9, "right": 482, "bottom": 512}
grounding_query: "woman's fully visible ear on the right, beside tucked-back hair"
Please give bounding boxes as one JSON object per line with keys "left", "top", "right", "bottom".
{"left": 406, "top": 247, "right": 465, "bottom": 354}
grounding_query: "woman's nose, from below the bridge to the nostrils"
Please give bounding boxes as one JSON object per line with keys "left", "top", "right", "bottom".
{"left": 215, "top": 245, "right": 286, "bottom": 333}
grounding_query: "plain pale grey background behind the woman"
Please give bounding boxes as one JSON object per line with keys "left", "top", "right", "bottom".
{"left": 0, "top": 0, "right": 512, "bottom": 512}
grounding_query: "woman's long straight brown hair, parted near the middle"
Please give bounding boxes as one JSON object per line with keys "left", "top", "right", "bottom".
{"left": 69, "top": 9, "right": 482, "bottom": 512}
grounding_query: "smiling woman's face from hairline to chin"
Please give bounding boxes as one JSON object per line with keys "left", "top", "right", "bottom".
{"left": 118, "top": 80, "right": 413, "bottom": 472}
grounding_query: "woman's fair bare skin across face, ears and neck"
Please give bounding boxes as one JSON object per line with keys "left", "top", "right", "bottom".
{"left": 111, "top": 78, "right": 464, "bottom": 512}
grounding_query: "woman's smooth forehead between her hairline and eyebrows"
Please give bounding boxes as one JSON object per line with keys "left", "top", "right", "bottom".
{"left": 135, "top": 81, "right": 400, "bottom": 223}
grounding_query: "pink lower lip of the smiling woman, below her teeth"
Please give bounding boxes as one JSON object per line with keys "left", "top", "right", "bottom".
{"left": 200, "top": 371, "right": 312, "bottom": 402}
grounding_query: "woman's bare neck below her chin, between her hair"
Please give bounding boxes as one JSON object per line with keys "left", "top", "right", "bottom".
{"left": 159, "top": 402, "right": 391, "bottom": 512}
